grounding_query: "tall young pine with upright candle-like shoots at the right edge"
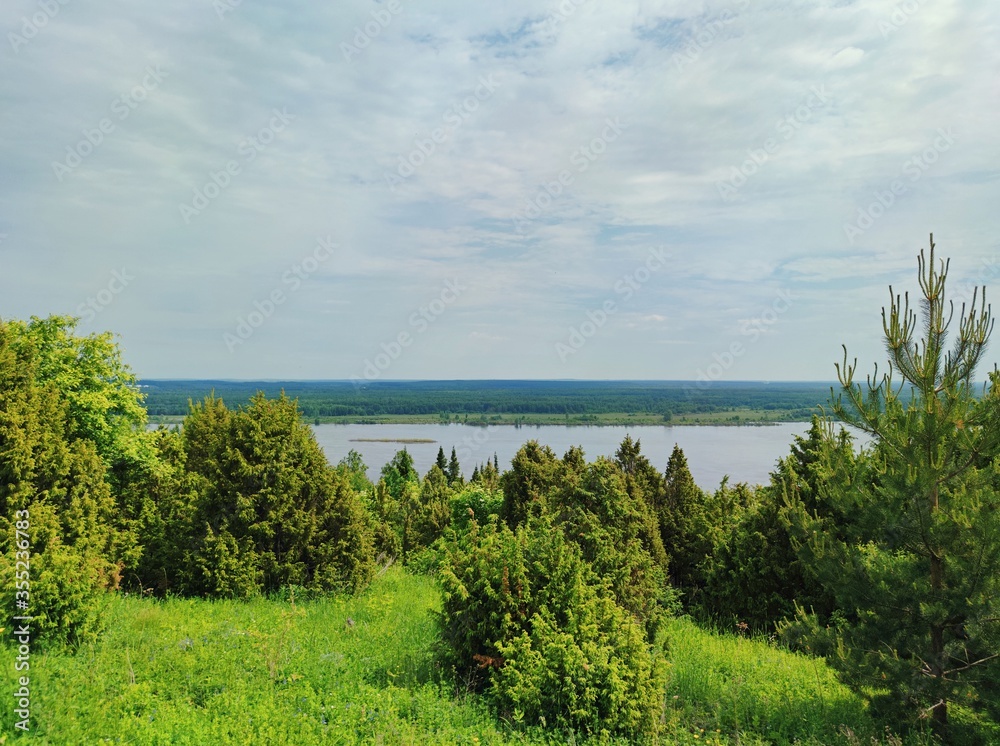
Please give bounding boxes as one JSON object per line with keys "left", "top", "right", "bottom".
{"left": 785, "top": 236, "right": 1000, "bottom": 741}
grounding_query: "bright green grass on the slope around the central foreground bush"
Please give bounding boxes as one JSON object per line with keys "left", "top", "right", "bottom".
{"left": 0, "top": 568, "right": 928, "bottom": 746}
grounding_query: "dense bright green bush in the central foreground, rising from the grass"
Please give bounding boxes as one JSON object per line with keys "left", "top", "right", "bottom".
{"left": 440, "top": 518, "right": 665, "bottom": 736}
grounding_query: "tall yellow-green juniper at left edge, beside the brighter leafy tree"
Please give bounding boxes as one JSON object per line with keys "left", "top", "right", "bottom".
{"left": 0, "top": 322, "right": 125, "bottom": 644}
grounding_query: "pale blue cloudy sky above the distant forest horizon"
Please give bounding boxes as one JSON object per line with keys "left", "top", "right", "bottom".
{"left": 0, "top": 0, "right": 1000, "bottom": 381}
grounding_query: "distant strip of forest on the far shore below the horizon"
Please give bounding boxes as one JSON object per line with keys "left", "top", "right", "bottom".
{"left": 141, "top": 379, "right": 831, "bottom": 421}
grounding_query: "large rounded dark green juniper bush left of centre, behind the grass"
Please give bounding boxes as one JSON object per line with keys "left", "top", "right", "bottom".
{"left": 163, "top": 395, "right": 374, "bottom": 597}
